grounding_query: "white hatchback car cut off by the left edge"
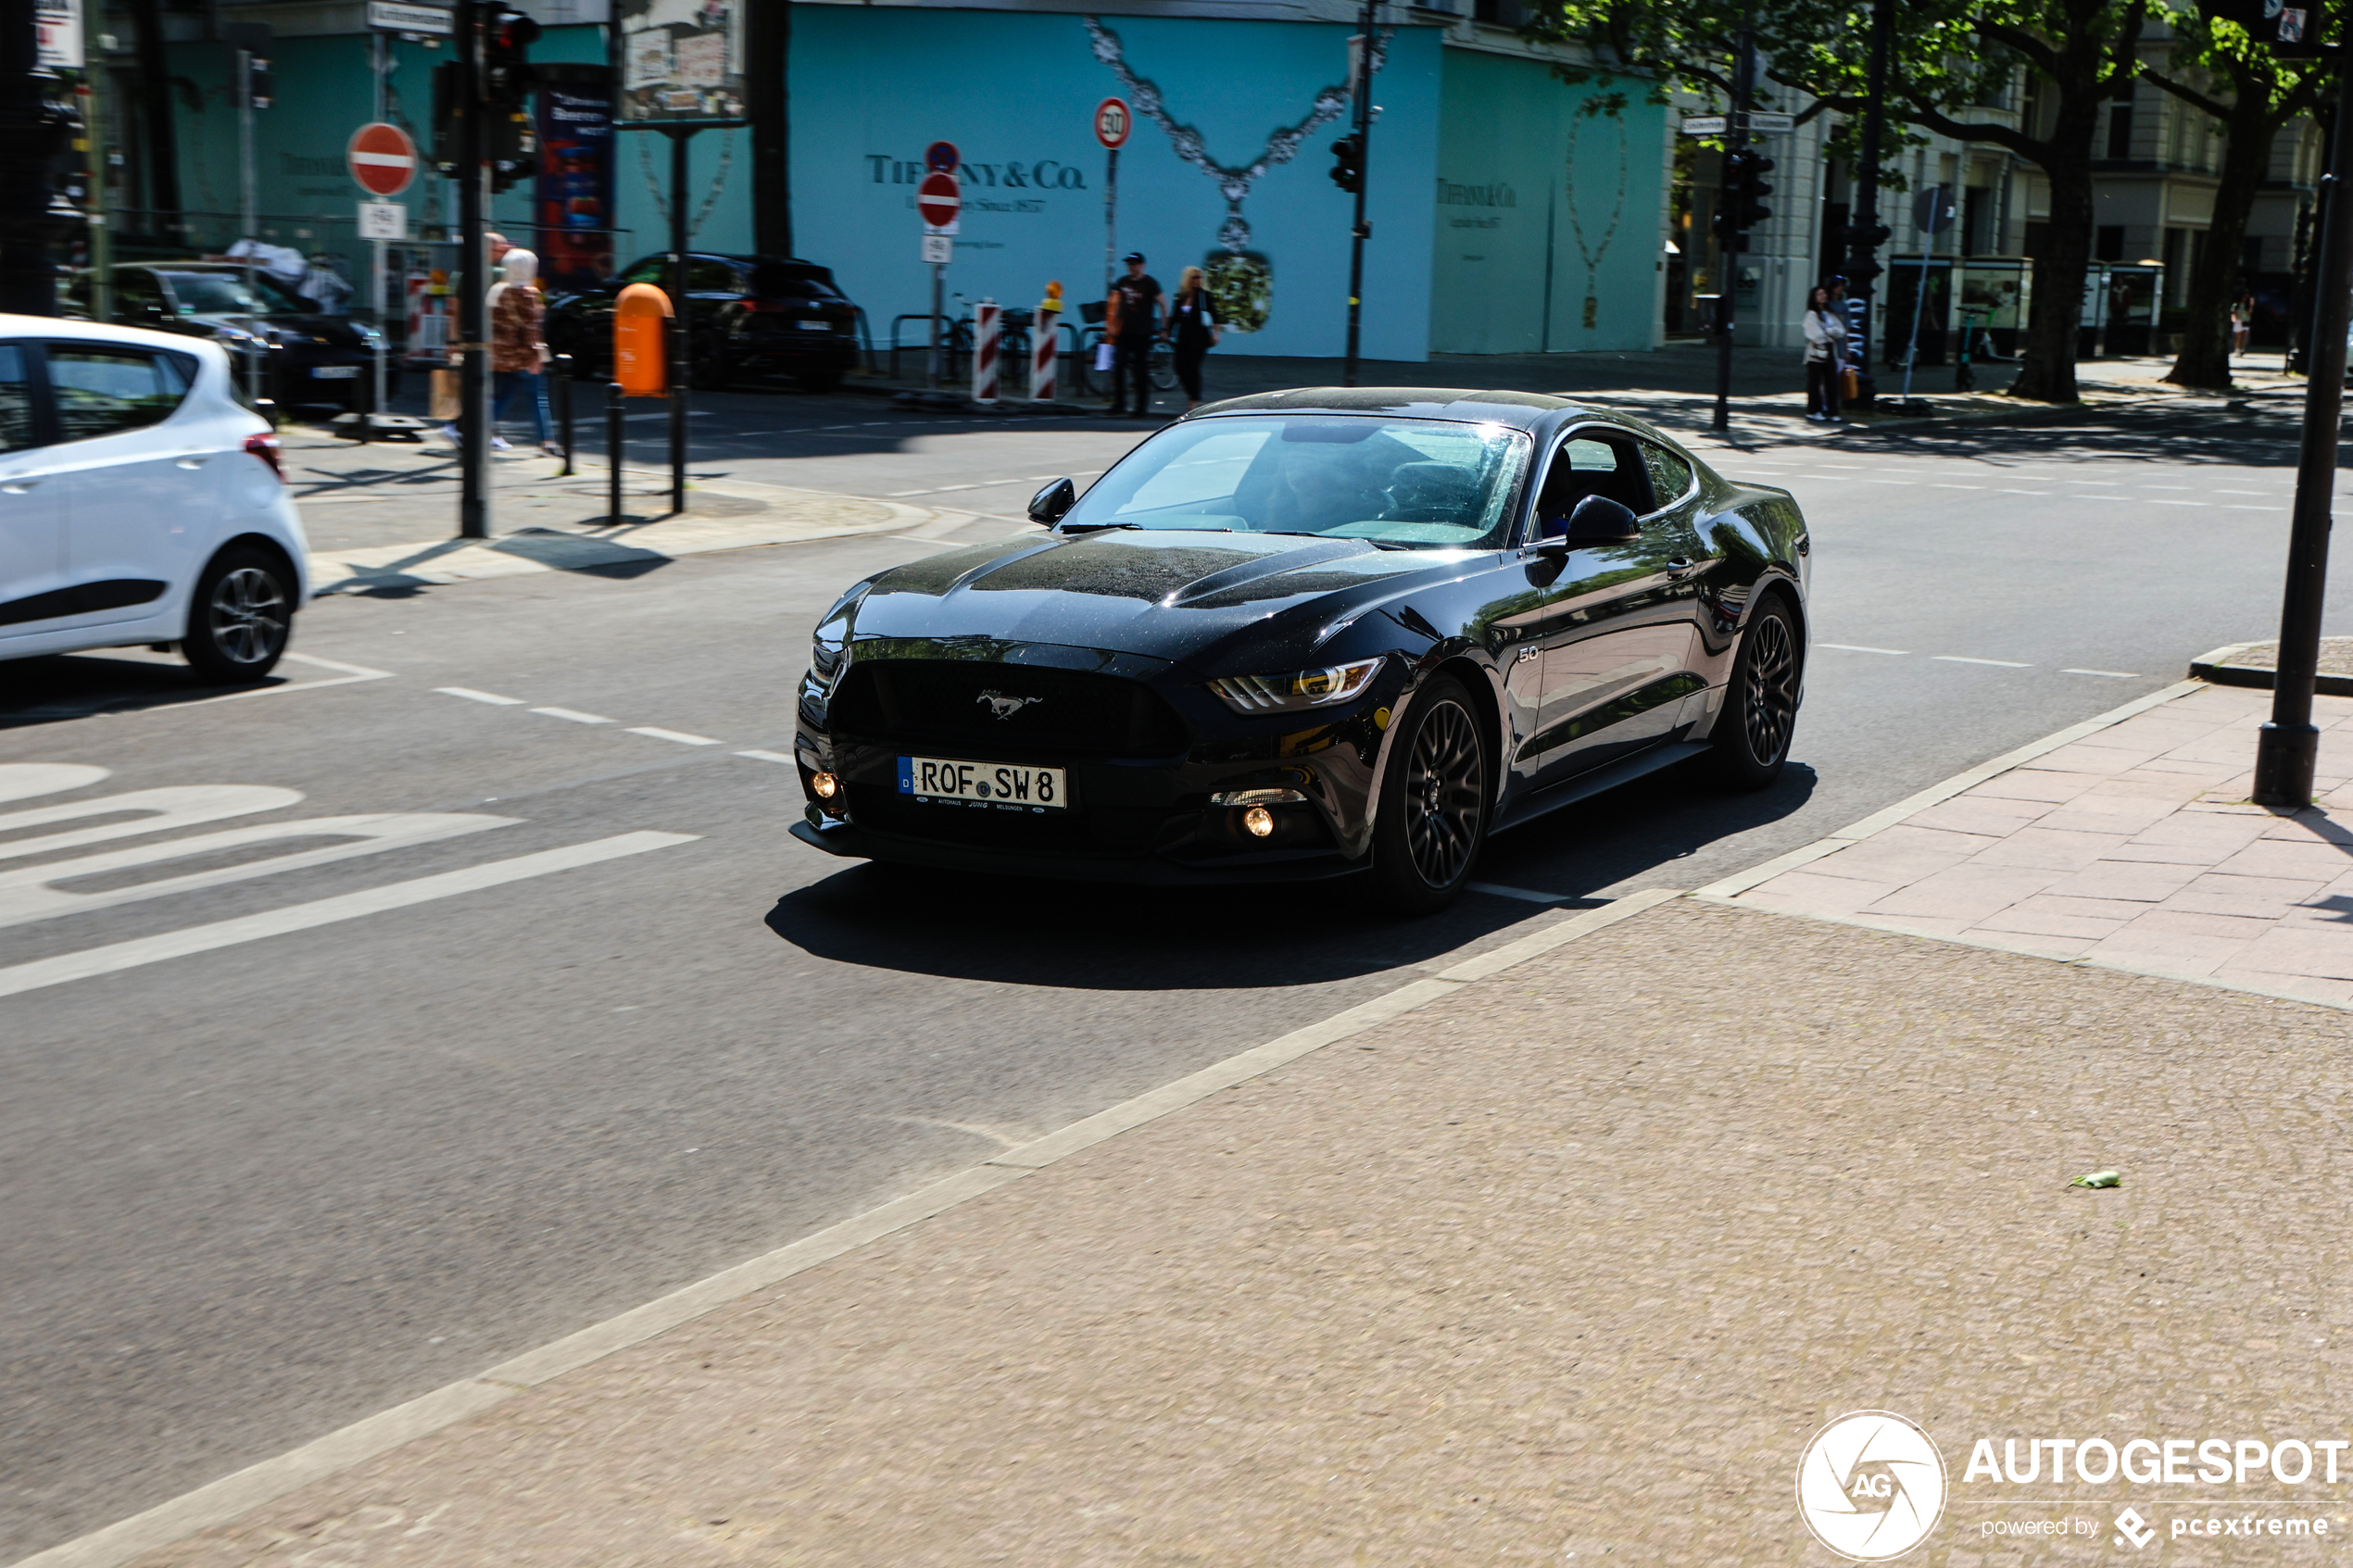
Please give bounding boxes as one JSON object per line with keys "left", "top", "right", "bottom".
{"left": 0, "top": 315, "right": 308, "bottom": 682}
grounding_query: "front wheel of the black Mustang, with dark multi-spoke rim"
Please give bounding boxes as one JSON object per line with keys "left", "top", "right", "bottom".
{"left": 1372, "top": 677, "right": 1487, "bottom": 914}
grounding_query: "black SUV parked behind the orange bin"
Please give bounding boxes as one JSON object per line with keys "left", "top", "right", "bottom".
{"left": 546, "top": 252, "right": 859, "bottom": 393}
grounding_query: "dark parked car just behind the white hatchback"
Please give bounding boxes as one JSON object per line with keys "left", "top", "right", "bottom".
{"left": 66, "top": 261, "right": 400, "bottom": 411}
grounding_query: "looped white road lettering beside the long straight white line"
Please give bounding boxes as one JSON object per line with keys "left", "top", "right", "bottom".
{"left": 0, "top": 811, "right": 520, "bottom": 926}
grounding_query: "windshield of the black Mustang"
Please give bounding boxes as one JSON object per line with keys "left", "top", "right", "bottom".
{"left": 1062, "top": 414, "right": 1527, "bottom": 550}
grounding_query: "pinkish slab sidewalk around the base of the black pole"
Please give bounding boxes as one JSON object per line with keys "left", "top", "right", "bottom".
{"left": 1739, "top": 686, "right": 2353, "bottom": 1004}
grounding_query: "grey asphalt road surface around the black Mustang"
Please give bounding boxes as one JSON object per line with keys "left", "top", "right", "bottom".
{"left": 0, "top": 395, "right": 2353, "bottom": 1561}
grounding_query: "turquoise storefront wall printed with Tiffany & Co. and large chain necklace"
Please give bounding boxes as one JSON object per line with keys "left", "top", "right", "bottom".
{"left": 790, "top": 5, "right": 1440, "bottom": 359}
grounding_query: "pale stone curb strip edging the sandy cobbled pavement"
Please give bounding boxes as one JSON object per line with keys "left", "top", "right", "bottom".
{"left": 9, "top": 888, "right": 1682, "bottom": 1568}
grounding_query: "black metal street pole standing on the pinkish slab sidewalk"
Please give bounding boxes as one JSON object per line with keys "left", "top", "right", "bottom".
{"left": 2254, "top": 44, "right": 2353, "bottom": 809}
